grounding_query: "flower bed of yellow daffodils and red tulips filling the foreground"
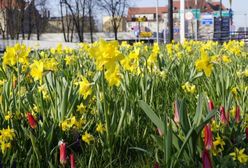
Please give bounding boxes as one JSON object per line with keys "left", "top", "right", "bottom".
{"left": 0, "top": 40, "right": 248, "bottom": 167}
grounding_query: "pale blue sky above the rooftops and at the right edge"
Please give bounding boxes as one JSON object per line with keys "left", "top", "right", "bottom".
{"left": 50, "top": 0, "right": 248, "bottom": 28}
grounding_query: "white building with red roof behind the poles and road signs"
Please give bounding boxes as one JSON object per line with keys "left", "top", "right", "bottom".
{"left": 127, "top": 0, "right": 226, "bottom": 38}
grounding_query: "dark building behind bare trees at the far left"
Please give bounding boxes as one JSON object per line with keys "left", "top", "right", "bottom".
{"left": 0, "top": 0, "right": 47, "bottom": 39}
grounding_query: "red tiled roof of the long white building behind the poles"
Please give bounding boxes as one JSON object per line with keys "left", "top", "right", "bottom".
{"left": 127, "top": 0, "right": 226, "bottom": 21}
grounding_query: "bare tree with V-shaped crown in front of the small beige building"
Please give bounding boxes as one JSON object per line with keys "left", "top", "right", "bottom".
{"left": 97, "top": 0, "right": 129, "bottom": 40}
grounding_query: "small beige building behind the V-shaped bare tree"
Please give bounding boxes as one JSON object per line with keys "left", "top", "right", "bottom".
{"left": 102, "top": 16, "right": 127, "bottom": 32}
